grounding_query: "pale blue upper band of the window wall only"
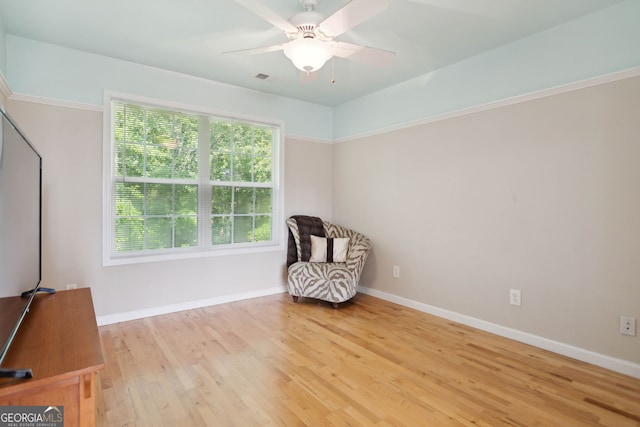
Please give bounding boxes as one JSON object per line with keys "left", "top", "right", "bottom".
{"left": 6, "top": 35, "right": 333, "bottom": 141}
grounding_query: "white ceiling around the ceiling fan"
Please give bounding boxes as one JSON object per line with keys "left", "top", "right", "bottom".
{"left": 0, "top": 0, "right": 622, "bottom": 106}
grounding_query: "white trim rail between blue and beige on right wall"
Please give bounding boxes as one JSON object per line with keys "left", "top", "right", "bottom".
{"left": 333, "top": 67, "right": 640, "bottom": 144}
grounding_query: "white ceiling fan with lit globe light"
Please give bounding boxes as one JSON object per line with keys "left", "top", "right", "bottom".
{"left": 225, "top": 0, "right": 395, "bottom": 74}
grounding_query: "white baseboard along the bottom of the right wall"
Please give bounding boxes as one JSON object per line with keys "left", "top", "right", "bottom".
{"left": 358, "top": 286, "right": 640, "bottom": 378}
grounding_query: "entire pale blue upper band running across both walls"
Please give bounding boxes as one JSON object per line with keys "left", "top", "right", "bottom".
{"left": 0, "top": 0, "right": 640, "bottom": 141}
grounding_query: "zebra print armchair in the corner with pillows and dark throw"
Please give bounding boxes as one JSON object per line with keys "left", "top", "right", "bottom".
{"left": 287, "top": 215, "right": 371, "bottom": 308}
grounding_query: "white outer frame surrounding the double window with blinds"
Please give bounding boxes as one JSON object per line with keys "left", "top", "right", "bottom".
{"left": 102, "top": 91, "right": 285, "bottom": 266}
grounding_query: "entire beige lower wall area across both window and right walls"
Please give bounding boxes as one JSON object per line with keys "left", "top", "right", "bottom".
{"left": 3, "top": 74, "right": 640, "bottom": 363}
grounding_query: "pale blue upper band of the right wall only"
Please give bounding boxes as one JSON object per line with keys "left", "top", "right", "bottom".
{"left": 334, "top": 0, "right": 640, "bottom": 139}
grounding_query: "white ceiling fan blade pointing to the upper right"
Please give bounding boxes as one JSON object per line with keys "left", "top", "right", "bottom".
{"left": 318, "top": 0, "right": 388, "bottom": 38}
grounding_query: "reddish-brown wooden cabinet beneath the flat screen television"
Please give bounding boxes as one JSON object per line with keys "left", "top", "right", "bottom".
{"left": 0, "top": 288, "right": 104, "bottom": 427}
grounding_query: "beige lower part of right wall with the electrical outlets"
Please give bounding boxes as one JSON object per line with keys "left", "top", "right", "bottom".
{"left": 333, "top": 77, "right": 640, "bottom": 363}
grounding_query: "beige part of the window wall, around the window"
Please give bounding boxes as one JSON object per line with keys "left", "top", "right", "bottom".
{"left": 8, "top": 100, "right": 332, "bottom": 316}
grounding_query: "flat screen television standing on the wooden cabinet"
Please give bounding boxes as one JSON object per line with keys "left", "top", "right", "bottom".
{"left": 0, "top": 110, "right": 50, "bottom": 378}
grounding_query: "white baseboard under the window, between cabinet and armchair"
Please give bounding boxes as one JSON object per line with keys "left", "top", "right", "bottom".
{"left": 97, "top": 286, "right": 287, "bottom": 326}
